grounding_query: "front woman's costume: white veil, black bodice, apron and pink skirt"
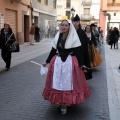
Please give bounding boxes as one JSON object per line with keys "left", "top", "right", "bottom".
{"left": 43, "top": 20, "right": 91, "bottom": 106}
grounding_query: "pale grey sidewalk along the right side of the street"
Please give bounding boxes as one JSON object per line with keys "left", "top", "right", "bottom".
{"left": 105, "top": 40, "right": 120, "bottom": 120}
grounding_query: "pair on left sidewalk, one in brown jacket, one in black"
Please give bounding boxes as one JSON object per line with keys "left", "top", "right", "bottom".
{"left": 30, "top": 23, "right": 41, "bottom": 45}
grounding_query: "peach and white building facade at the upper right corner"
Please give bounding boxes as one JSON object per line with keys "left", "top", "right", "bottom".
{"left": 100, "top": 0, "right": 120, "bottom": 34}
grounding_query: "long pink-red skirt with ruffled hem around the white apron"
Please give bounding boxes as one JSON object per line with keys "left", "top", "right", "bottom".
{"left": 43, "top": 56, "right": 91, "bottom": 106}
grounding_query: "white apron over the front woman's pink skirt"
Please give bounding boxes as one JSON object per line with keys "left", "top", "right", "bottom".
{"left": 52, "top": 55, "right": 73, "bottom": 91}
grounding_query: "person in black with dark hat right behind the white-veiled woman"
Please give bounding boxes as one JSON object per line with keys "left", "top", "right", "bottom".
{"left": 72, "top": 15, "right": 92, "bottom": 79}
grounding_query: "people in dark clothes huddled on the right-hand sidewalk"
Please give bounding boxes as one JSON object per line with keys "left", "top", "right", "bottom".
{"left": 108, "top": 27, "right": 120, "bottom": 49}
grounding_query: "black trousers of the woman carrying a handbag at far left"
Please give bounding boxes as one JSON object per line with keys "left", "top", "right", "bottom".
{"left": 1, "top": 49, "right": 11, "bottom": 68}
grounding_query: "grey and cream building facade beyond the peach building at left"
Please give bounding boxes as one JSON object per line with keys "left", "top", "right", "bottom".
{"left": 32, "top": 0, "right": 57, "bottom": 37}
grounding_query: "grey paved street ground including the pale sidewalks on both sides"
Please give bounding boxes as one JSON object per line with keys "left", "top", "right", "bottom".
{"left": 0, "top": 40, "right": 120, "bottom": 120}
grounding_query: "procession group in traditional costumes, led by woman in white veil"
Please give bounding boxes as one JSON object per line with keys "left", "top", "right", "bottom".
{"left": 42, "top": 15, "right": 102, "bottom": 114}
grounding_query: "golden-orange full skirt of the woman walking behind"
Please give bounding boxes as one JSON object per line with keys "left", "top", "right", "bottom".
{"left": 88, "top": 44, "right": 102, "bottom": 68}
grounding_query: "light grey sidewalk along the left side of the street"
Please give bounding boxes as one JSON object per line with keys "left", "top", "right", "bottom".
{"left": 0, "top": 39, "right": 51, "bottom": 71}
